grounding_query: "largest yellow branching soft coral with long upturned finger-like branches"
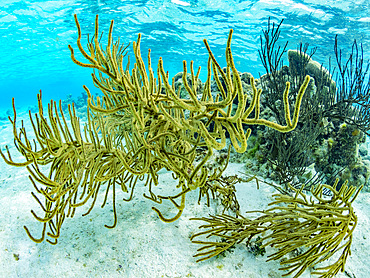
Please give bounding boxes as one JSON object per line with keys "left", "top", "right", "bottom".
{"left": 1, "top": 13, "right": 310, "bottom": 243}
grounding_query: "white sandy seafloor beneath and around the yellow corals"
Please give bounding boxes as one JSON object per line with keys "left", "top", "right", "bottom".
{"left": 0, "top": 113, "right": 370, "bottom": 278}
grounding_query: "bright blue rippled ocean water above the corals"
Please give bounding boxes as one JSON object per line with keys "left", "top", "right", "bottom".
{"left": 0, "top": 0, "right": 370, "bottom": 114}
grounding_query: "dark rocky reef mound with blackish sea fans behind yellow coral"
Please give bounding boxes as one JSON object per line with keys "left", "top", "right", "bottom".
{"left": 243, "top": 19, "right": 370, "bottom": 191}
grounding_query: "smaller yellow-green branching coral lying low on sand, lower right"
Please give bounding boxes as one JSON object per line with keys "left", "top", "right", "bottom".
{"left": 191, "top": 180, "right": 362, "bottom": 277}
